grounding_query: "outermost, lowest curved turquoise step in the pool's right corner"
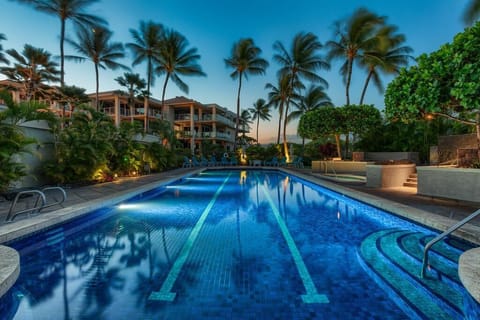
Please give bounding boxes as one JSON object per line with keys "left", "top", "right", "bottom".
{"left": 360, "top": 229, "right": 452, "bottom": 319}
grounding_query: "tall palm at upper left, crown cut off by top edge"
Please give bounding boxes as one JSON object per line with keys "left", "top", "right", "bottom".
{"left": 16, "top": 0, "right": 107, "bottom": 86}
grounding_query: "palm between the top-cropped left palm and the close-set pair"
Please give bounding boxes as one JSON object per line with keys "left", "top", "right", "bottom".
{"left": 65, "top": 27, "right": 128, "bottom": 111}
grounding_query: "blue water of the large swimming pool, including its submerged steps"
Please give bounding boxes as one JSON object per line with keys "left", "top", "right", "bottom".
{"left": 0, "top": 170, "right": 480, "bottom": 320}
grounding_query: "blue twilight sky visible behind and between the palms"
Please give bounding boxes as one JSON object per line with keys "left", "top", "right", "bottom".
{"left": 0, "top": 0, "right": 468, "bottom": 143}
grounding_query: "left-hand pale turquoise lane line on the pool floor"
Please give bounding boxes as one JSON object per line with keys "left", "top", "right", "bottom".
{"left": 148, "top": 172, "right": 232, "bottom": 301}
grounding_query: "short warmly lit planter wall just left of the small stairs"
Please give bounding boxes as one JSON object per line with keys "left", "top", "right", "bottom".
{"left": 367, "top": 163, "right": 416, "bottom": 188}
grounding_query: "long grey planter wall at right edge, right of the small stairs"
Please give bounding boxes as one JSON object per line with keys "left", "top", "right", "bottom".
{"left": 417, "top": 167, "right": 480, "bottom": 203}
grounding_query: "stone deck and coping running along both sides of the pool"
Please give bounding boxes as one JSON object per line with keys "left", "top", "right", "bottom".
{"left": 0, "top": 167, "right": 480, "bottom": 302}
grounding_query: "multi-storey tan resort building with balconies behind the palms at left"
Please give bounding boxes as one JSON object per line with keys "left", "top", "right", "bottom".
{"left": 0, "top": 80, "right": 250, "bottom": 154}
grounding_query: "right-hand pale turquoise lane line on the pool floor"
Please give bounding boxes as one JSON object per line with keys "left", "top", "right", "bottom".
{"left": 255, "top": 174, "right": 330, "bottom": 303}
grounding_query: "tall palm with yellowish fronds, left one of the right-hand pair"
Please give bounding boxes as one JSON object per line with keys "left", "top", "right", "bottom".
{"left": 326, "top": 8, "right": 384, "bottom": 105}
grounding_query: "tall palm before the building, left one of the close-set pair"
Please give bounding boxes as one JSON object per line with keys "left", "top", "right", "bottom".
{"left": 126, "top": 21, "right": 164, "bottom": 132}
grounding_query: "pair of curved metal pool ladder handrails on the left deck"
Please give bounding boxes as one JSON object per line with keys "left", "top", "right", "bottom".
{"left": 5, "top": 187, "right": 67, "bottom": 222}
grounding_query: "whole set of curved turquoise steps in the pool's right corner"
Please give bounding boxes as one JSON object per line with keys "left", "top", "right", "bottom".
{"left": 360, "top": 229, "right": 463, "bottom": 319}
